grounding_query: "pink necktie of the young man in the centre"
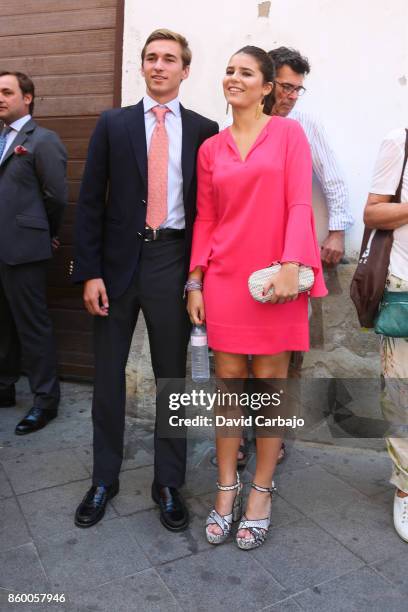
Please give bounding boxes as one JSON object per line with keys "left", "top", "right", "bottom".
{"left": 146, "top": 106, "right": 169, "bottom": 229}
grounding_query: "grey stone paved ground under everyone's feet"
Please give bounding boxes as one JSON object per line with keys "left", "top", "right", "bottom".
{"left": 0, "top": 381, "right": 408, "bottom": 612}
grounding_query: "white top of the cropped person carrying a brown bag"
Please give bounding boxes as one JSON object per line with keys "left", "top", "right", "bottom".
{"left": 370, "top": 128, "right": 408, "bottom": 281}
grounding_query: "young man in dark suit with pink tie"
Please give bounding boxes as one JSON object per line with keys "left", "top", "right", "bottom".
{"left": 73, "top": 30, "right": 218, "bottom": 531}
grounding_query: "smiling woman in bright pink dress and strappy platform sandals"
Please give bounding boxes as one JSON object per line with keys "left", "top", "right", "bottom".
{"left": 187, "top": 46, "right": 327, "bottom": 549}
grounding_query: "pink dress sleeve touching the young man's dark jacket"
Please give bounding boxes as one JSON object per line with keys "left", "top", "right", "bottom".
{"left": 190, "top": 137, "right": 217, "bottom": 272}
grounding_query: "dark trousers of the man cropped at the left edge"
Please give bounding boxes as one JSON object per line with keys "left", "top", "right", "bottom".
{"left": 0, "top": 261, "right": 60, "bottom": 410}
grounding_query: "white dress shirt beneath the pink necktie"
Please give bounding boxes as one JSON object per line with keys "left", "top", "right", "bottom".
{"left": 143, "top": 95, "right": 185, "bottom": 229}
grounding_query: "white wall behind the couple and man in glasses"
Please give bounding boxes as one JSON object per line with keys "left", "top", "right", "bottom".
{"left": 122, "top": 0, "right": 408, "bottom": 255}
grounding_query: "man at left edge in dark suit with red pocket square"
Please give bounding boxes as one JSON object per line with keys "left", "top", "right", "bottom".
{"left": 0, "top": 71, "right": 67, "bottom": 435}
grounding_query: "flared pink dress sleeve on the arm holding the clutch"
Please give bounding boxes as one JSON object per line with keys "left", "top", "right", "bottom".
{"left": 281, "top": 121, "right": 327, "bottom": 297}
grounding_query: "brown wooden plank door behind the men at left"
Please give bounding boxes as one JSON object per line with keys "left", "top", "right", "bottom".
{"left": 0, "top": 0, "right": 124, "bottom": 380}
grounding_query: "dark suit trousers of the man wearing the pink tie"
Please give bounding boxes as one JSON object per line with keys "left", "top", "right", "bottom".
{"left": 92, "top": 239, "right": 191, "bottom": 487}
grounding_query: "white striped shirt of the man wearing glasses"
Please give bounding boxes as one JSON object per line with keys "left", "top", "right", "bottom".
{"left": 224, "top": 109, "right": 354, "bottom": 231}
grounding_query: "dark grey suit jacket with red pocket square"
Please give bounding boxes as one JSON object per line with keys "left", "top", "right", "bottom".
{"left": 0, "top": 119, "right": 67, "bottom": 265}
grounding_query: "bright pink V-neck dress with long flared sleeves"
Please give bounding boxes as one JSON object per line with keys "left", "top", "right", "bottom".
{"left": 190, "top": 116, "right": 327, "bottom": 355}
